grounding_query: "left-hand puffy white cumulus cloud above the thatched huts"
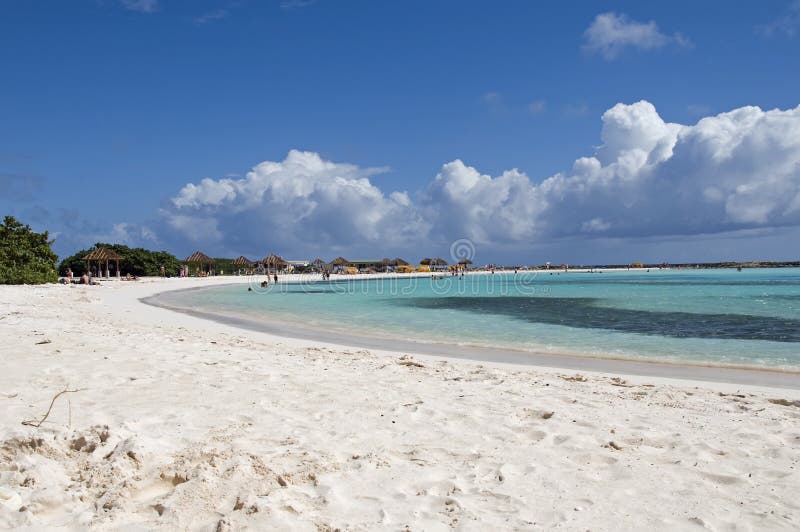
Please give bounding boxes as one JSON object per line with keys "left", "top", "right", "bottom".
{"left": 162, "top": 150, "right": 427, "bottom": 256}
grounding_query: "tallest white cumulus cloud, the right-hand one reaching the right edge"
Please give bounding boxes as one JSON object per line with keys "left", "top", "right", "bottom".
{"left": 430, "top": 101, "right": 800, "bottom": 241}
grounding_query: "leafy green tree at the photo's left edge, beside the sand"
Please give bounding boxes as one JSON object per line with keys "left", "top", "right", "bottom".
{"left": 0, "top": 216, "right": 58, "bottom": 284}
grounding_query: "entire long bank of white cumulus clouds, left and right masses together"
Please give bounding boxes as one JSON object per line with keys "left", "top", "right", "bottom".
{"left": 163, "top": 101, "right": 800, "bottom": 258}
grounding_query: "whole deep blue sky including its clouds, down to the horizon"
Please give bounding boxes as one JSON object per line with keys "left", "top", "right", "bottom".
{"left": 0, "top": 0, "right": 800, "bottom": 263}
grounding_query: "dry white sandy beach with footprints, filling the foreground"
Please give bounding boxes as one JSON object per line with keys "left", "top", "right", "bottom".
{"left": 0, "top": 279, "right": 800, "bottom": 530}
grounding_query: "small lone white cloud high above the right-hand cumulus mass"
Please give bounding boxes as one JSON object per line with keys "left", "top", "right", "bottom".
{"left": 583, "top": 12, "right": 691, "bottom": 60}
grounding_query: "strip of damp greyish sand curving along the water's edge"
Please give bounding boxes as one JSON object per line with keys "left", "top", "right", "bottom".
{"left": 144, "top": 280, "right": 800, "bottom": 389}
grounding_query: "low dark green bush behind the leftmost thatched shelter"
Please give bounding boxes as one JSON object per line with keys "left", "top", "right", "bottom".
{"left": 58, "top": 242, "right": 181, "bottom": 276}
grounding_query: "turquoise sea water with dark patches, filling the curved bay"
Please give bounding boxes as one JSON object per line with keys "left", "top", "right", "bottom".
{"left": 155, "top": 268, "right": 800, "bottom": 369}
